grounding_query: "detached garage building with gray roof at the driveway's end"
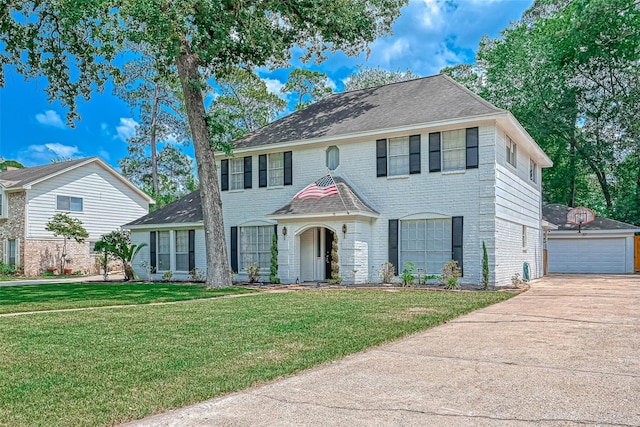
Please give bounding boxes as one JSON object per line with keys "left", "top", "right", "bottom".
{"left": 542, "top": 204, "right": 640, "bottom": 274}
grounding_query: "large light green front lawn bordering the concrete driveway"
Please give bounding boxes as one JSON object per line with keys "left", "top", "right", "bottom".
{"left": 0, "top": 287, "right": 513, "bottom": 426}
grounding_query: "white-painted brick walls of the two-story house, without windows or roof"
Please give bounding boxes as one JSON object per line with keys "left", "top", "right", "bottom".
{"left": 127, "top": 119, "right": 542, "bottom": 286}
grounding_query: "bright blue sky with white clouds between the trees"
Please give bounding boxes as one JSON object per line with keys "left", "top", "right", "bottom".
{"left": 0, "top": 0, "right": 533, "bottom": 168}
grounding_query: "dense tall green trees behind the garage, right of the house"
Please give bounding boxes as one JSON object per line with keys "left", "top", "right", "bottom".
{"left": 443, "top": 0, "right": 640, "bottom": 223}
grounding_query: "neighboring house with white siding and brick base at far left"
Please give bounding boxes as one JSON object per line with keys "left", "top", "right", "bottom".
{"left": 0, "top": 157, "right": 153, "bottom": 275}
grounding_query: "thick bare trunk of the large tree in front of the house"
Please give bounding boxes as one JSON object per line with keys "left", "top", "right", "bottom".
{"left": 176, "top": 39, "right": 231, "bottom": 288}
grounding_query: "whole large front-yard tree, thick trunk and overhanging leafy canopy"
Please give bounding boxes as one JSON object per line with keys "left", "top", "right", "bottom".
{"left": 0, "top": 0, "right": 407, "bottom": 287}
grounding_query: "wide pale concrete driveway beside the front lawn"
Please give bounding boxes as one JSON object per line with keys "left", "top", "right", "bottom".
{"left": 122, "top": 275, "right": 640, "bottom": 426}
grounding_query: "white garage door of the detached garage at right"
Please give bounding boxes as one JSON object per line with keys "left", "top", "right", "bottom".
{"left": 547, "top": 238, "right": 626, "bottom": 273}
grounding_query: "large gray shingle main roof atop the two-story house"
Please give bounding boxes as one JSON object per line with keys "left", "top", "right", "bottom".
{"left": 234, "top": 74, "right": 504, "bottom": 148}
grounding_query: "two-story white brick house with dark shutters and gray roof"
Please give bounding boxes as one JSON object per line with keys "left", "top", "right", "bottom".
{"left": 126, "top": 75, "right": 552, "bottom": 286}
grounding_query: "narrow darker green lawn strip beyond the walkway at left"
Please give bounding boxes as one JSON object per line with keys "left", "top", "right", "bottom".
{"left": 0, "top": 283, "right": 251, "bottom": 314}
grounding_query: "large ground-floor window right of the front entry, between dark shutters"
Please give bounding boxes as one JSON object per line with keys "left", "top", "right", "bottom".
{"left": 398, "top": 219, "right": 452, "bottom": 274}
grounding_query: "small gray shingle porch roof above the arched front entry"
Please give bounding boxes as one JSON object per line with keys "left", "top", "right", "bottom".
{"left": 271, "top": 177, "right": 378, "bottom": 215}
